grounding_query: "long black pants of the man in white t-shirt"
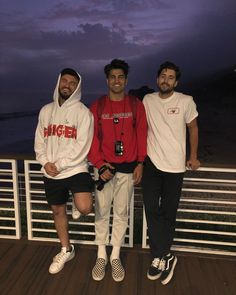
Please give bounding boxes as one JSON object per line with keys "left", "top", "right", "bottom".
{"left": 143, "top": 157, "right": 184, "bottom": 258}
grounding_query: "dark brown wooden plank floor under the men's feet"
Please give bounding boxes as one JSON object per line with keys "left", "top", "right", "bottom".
{"left": 0, "top": 239, "right": 236, "bottom": 295}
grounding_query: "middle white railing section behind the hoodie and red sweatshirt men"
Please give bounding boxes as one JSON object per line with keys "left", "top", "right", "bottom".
{"left": 24, "top": 160, "right": 134, "bottom": 247}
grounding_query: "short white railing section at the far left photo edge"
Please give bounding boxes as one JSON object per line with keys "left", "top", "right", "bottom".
{"left": 0, "top": 159, "right": 21, "bottom": 239}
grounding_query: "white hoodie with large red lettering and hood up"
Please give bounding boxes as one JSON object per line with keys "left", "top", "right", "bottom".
{"left": 34, "top": 74, "right": 93, "bottom": 179}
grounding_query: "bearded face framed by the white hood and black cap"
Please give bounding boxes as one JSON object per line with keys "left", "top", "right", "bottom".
{"left": 59, "top": 74, "right": 79, "bottom": 100}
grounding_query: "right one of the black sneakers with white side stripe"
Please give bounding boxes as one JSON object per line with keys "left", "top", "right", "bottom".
{"left": 159, "top": 253, "right": 177, "bottom": 285}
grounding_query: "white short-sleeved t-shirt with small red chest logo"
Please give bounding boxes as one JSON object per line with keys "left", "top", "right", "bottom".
{"left": 143, "top": 92, "right": 198, "bottom": 173}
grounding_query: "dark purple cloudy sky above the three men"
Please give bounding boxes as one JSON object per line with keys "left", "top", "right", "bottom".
{"left": 0, "top": 0, "right": 236, "bottom": 113}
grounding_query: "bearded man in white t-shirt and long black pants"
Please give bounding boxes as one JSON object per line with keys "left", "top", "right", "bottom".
{"left": 143, "top": 62, "right": 200, "bottom": 285}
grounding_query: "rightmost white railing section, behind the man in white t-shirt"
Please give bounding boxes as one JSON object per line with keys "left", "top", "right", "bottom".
{"left": 142, "top": 167, "right": 236, "bottom": 256}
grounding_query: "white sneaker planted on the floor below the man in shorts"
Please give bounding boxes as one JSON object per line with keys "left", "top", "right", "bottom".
{"left": 48, "top": 245, "right": 75, "bottom": 274}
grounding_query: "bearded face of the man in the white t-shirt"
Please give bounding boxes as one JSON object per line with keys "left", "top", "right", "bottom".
{"left": 157, "top": 69, "right": 178, "bottom": 94}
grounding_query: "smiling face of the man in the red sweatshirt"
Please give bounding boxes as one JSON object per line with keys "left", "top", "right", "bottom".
{"left": 107, "top": 69, "right": 127, "bottom": 94}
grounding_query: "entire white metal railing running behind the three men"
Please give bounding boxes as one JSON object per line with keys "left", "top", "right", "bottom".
{"left": 0, "top": 159, "right": 236, "bottom": 256}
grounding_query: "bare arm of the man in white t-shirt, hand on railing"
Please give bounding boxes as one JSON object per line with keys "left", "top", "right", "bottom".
{"left": 187, "top": 118, "right": 200, "bottom": 170}
